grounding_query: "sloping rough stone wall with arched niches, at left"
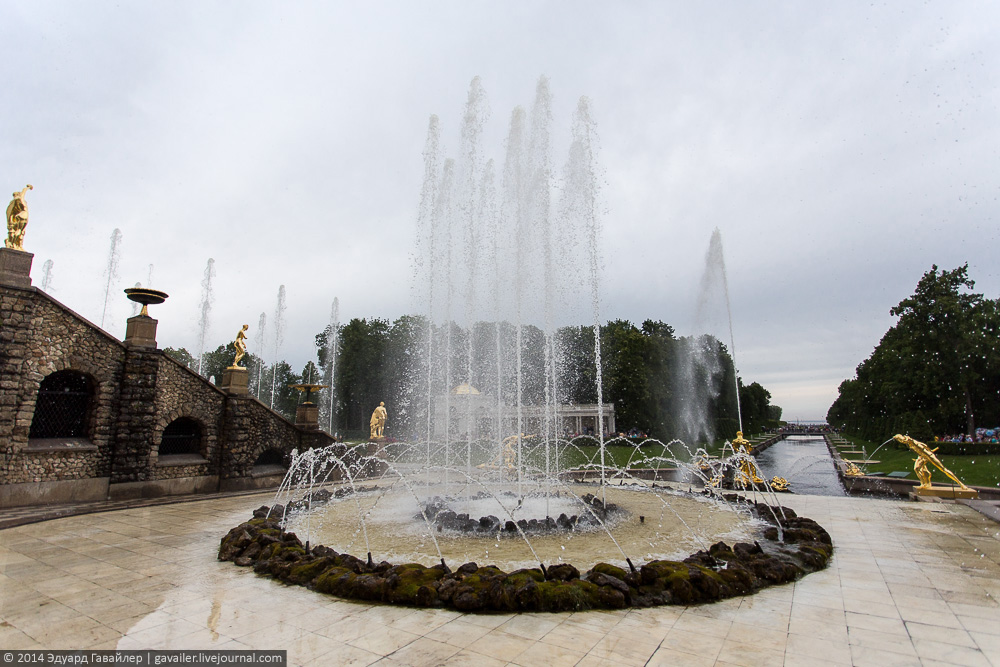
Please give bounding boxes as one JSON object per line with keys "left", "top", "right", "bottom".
{"left": 0, "top": 283, "right": 332, "bottom": 506}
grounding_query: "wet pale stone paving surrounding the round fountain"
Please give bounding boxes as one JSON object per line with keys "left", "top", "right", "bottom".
{"left": 0, "top": 494, "right": 1000, "bottom": 667}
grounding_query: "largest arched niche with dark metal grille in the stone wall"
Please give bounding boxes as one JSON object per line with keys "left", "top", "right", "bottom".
{"left": 28, "top": 371, "right": 93, "bottom": 438}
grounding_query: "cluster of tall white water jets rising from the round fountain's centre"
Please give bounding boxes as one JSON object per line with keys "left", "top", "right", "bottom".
{"left": 414, "top": 77, "right": 604, "bottom": 498}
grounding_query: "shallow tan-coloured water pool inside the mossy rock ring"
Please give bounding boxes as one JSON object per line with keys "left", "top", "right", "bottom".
{"left": 286, "top": 484, "right": 762, "bottom": 570}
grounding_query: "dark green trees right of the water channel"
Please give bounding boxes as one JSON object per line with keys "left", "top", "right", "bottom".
{"left": 827, "top": 264, "right": 1000, "bottom": 441}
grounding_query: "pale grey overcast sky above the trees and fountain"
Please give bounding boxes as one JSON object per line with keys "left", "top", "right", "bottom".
{"left": 0, "top": 0, "right": 1000, "bottom": 419}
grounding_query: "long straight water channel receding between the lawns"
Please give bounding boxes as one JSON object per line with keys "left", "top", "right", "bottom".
{"left": 757, "top": 435, "right": 846, "bottom": 496}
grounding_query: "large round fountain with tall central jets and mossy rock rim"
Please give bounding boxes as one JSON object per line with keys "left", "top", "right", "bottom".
{"left": 219, "top": 78, "right": 832, "bottom": 611}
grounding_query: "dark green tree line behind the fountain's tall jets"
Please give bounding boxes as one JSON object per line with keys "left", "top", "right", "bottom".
{"left": 165, "top": 315, "right": 781, "bottom": 443}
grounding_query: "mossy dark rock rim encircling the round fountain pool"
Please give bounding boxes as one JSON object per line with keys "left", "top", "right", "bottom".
{"left": 219, "top": 490, "right": 833, "bottom": 612}
